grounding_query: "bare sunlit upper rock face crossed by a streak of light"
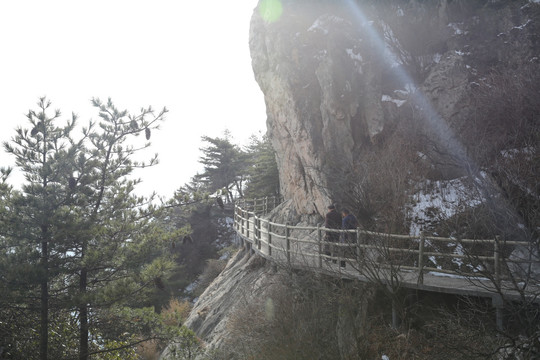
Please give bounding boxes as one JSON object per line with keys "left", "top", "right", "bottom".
{"left": 250, "top": 0, "right": 540, "bottom": 215}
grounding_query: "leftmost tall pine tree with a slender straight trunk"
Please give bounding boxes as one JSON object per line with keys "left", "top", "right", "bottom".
{"left": 3, "top": 98, "right": 80, "bottom": 360}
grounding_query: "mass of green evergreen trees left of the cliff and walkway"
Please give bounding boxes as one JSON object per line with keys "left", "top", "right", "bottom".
{"left": 0, "top": 98, "right": 279, "bottom": 360}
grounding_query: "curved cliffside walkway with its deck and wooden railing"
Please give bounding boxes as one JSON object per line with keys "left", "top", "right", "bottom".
{"left": 234, "top": 199, "right": 540, "bottom": 307}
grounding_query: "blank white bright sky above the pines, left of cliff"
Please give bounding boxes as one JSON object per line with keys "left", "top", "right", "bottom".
{"left": 0, "top": 0, "right": 266, "bottom": 197}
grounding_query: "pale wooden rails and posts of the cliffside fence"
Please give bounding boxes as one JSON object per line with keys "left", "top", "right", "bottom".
{"left": 234, "top": 198, "right": 534, "bottom": 284}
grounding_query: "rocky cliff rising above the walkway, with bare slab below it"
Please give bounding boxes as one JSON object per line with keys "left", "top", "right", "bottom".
{"left": 162, "top": 0, "right": 540, "bottom": 358}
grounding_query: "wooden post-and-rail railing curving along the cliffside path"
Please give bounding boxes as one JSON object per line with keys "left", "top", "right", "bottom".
{"left": 234, "top": 198, "right": 538, "bottom": 289}
